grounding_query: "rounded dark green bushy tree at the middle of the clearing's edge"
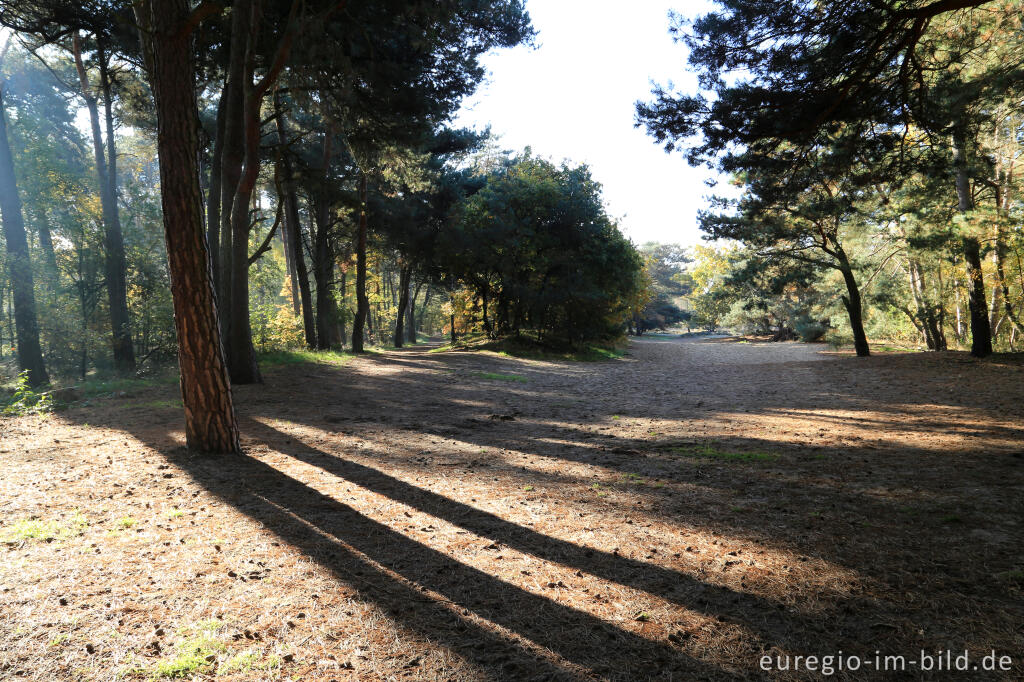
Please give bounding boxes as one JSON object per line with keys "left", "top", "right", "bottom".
{"left": 440, "top": 153, "right": 642, "bottom": 345}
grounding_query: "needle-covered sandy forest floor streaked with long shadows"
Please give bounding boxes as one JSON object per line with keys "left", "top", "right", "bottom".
{"left": 0, "top": 338, "right": 1024, "bottom": 680}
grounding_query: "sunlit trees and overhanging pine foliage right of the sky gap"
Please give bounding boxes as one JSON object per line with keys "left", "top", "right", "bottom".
{"left": 637, "top": 0, "right": 1024, "bottom": 356}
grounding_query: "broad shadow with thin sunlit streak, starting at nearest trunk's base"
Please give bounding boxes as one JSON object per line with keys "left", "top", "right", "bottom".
{"left": 157, "top": 438, "right": 722, "bottom": 679}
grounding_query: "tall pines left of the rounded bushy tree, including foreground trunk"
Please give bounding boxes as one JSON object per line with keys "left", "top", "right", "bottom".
{"left": 0, "top": 0, "right": 565, "bottom": 452}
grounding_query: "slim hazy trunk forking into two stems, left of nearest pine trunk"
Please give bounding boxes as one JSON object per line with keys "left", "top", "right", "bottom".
{"left": 72, "top": 33, "right": 135, "bottom": 374}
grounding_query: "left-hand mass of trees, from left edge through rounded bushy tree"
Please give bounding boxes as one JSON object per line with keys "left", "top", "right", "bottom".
{"left": 0, "top": 0, "right": 642, "bottom": 452}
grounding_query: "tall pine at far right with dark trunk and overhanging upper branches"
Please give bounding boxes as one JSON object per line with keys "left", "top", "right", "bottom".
{"left": 638, "top": 0, "right": 1024, "bottom": 356}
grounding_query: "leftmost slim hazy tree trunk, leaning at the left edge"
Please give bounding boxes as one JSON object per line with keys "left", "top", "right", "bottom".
{"left": 0, "top": 82, "right": 50, "bottom": 386}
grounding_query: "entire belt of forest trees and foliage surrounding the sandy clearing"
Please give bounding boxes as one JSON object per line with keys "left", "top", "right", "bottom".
{"left": 0, "top": 0, "right": 1024, "bottom": 446}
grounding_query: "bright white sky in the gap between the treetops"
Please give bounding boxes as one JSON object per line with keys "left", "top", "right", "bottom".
{"left": 457, "top": 0, "right": 724, "bottom": 245}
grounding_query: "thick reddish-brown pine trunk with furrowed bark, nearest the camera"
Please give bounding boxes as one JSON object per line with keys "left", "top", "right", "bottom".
{"left": 135, "top": 0, "right": 242, "bottom": 453}
